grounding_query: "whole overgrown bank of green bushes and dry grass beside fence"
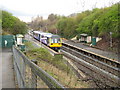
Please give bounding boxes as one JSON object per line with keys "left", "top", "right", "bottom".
{"left": 25, "top": 42, "right": 89, "bottom": 88}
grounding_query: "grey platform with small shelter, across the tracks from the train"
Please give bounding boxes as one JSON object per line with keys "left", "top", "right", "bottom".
{"left": 63, "top": 40, "right": 119, "bottom": 61}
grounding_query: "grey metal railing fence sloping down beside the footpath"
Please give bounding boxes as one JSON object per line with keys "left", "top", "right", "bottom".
{"left": 13, "top": 46, "right": 64, "bottom": 89}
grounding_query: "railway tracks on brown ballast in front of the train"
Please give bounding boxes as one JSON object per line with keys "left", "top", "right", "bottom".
{"left": 61, "top": 43, "right": 120, "bottom": 88}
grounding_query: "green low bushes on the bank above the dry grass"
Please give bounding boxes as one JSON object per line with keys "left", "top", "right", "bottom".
{"left": 25, "top": 42, "right": 68, "bottom": 71}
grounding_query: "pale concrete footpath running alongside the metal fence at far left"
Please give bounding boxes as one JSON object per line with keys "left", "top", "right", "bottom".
{"left": 0, "top": 49, "right": 15, "bottom": 88}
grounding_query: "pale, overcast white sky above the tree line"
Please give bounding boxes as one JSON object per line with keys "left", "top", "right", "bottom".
{"left": 0, "top": 0, "right": 120, "bottom": 22}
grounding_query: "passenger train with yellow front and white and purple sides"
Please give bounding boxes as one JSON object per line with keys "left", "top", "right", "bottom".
{"left": 33, "top": 31, "right": 62, "bottom": 51}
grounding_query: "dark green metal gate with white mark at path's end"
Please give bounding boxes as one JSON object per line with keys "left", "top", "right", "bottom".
{"left": 0, "top": 35, "right": 15, "bottom": 48}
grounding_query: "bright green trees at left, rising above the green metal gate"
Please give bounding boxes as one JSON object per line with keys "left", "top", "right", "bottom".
{"left": 0, "top": 10, "right": 27, "bottom": 35}
